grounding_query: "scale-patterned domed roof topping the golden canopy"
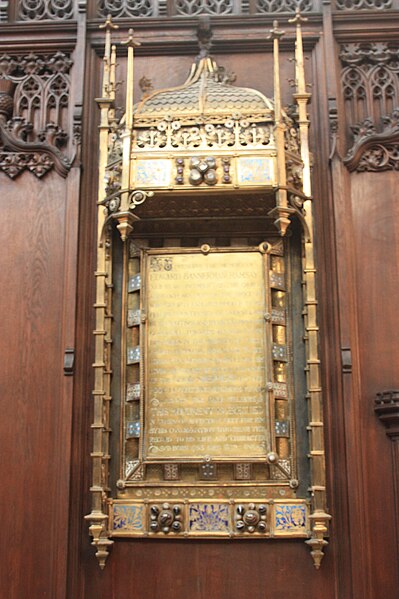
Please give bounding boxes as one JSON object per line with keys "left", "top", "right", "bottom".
{"left": 135, "top": 57, "right": 273, "bottom": 122}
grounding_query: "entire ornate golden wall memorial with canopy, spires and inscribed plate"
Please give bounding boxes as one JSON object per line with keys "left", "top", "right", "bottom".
{"left": 87, "top": 12, "right": 330, "bottom": 567}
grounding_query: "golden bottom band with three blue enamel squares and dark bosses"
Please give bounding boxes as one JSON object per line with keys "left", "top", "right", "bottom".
{"left": 109, "top": 500, "right": 311, "bottom": 538}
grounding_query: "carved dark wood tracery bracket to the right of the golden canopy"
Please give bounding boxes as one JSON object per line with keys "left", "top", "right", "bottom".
{"left": 340, "top": 42, "right": 399, "bottom": 171}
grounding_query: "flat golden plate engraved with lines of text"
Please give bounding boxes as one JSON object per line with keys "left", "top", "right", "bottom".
{"left": 144, "top": 251, "right": 270, "bottom": 461}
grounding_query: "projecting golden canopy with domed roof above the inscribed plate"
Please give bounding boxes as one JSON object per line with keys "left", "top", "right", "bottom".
{"left": 102, "top": 14, "right": 309, "bottom": 239}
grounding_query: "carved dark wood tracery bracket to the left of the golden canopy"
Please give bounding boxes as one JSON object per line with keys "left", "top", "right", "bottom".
{"left": 0, "top": 52, "right": 72, "bottom": 179}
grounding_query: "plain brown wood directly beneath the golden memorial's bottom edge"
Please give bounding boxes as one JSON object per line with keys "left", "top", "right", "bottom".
{"left": 79, "top": 540, "right": 336, "bottom": 599}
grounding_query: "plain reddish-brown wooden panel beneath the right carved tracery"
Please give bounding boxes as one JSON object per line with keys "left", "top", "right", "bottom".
{"left": 347, "top": 172, "right": 399, "bottom": 598}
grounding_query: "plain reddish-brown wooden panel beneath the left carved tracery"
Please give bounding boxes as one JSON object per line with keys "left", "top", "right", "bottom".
{"left": 0, "top": 173, "right": 74, "bottom": 599}
